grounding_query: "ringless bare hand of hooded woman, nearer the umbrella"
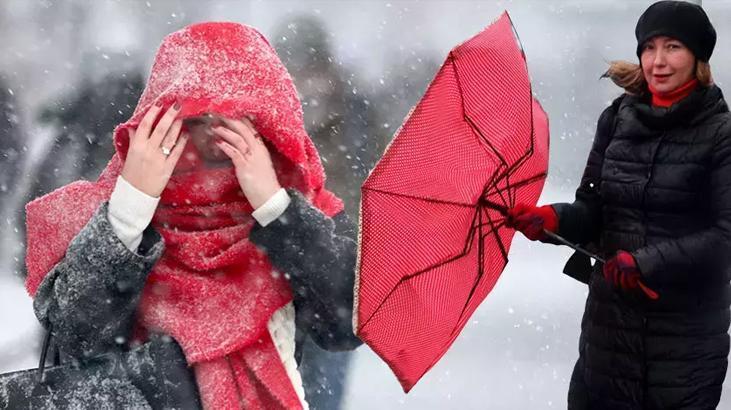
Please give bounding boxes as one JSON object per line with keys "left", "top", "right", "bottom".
{"left": 212, "top": 118, "right": 282, "bottom": 209}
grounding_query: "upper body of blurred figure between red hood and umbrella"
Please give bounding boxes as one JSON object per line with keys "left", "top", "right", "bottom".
{"left": 274, "top": 16, "right": 384, "bottom": 220}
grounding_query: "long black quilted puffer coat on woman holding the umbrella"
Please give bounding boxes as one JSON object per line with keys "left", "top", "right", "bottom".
{"left": 554, "top": 86, "right": 731, "bottom": 410}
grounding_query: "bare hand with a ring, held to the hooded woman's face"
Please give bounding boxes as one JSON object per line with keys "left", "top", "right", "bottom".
{"left": 122, "top": 103, "right": 188, "bottom": 198}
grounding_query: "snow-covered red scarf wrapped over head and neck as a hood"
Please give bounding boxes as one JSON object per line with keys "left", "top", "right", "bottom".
{"left": 26, "top": 23, "right": 343, "bottom": 409}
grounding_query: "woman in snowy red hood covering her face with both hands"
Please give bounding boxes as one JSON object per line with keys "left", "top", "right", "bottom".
{"left": 26, "top": 23, "right": 360, "bottom": 409}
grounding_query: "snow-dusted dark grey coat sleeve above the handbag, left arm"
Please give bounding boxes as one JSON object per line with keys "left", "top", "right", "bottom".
{"left": 33, "top": 202, "right": 164, "bottom": 358}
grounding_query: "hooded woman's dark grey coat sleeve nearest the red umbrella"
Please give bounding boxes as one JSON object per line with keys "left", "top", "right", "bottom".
{"left": 249, "top": 190, "right": 362, "bottom": 350}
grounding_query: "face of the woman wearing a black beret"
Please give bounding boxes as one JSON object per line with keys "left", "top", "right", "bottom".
{"left": 640, "top": 36, "right": 696, "bottom": 94}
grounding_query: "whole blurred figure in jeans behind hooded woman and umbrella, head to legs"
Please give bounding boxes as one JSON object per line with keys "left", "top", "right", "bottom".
{"left": 274, "top": 16, "right": 384, "bottom": 409}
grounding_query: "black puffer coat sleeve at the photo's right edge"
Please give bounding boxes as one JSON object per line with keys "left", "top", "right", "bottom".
{"left": 632, "top": 121, "right": 731, "bottom": 287}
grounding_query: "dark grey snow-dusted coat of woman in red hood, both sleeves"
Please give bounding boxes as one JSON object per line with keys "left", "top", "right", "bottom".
{"left": 34, "top": 191, "right": 362, "bottom": 406}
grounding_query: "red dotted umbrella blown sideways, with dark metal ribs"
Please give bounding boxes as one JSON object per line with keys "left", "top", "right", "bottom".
{"left": 354, "top": 13, "right": 548, "bottom": 392}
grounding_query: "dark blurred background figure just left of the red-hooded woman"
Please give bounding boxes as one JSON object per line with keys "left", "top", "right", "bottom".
{"left": 14, "top": 52, "right": 144, "bottom": 276}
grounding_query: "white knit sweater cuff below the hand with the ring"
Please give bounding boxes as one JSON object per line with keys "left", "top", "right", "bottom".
{"left": 108, "top": 175, "right": 160, "bottom": 252}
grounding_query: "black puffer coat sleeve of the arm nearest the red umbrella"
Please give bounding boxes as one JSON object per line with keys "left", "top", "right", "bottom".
{"left": 552, "top": 101, "right": 618, "bottom": 245}
